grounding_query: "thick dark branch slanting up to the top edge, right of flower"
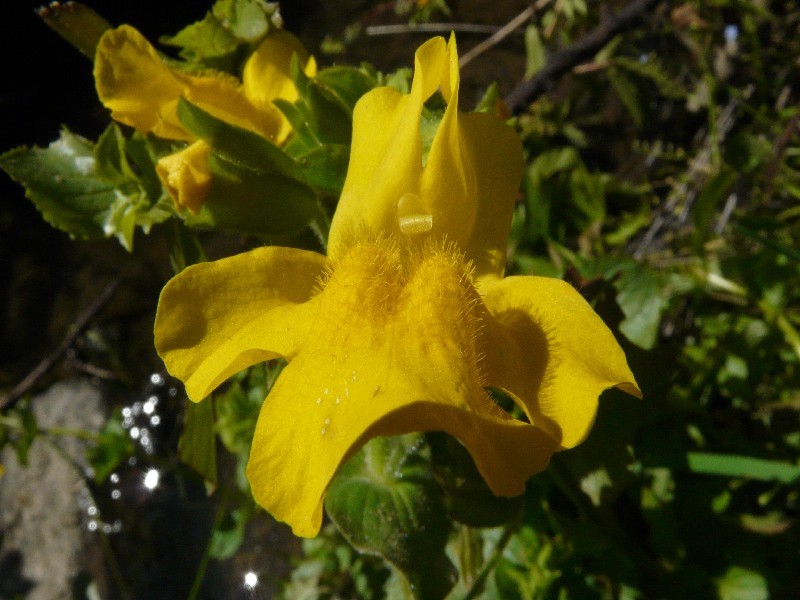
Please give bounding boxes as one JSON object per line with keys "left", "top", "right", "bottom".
{"left": 506, "top": 0, "right": 659, "bottom": 113}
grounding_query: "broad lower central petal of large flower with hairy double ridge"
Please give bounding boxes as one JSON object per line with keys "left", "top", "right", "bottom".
{"left": 247, "top": 240, "right": 556, "bottom": 536}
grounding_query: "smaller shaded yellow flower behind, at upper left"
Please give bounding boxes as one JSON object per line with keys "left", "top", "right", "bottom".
{"left": 94, "top": 25, "right": 316, "bottom": 213}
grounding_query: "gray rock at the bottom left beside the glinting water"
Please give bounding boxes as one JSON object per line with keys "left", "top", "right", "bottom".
{"left": 0, "top": 380, "right": 105, "bottom": 600}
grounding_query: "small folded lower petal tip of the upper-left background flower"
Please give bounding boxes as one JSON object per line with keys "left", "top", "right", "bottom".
{"left": 156, "top": 140, "right": 211, "bottom": 215}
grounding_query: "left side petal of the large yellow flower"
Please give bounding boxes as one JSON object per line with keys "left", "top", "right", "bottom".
{"left": 155, "top": 247, "right": 326, "bottom": 402}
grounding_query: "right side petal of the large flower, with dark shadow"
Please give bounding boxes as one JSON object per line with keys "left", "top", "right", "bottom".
{"left": 479, "top": 277, "right": 641, "bottom": 448}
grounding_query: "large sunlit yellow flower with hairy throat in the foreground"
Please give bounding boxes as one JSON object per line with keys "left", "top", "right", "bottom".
{"left": 155, "top": 38, "right": 639, "bottom": 536}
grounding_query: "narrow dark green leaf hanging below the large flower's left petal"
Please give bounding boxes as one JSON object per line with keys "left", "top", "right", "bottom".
{"left": 178, "top": 399, "right": 217, "bottom": 486}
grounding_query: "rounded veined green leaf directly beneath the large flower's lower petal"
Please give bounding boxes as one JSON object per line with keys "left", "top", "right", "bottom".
{"left": 325, "top": 435, "right": 454, "bottom": 599}
